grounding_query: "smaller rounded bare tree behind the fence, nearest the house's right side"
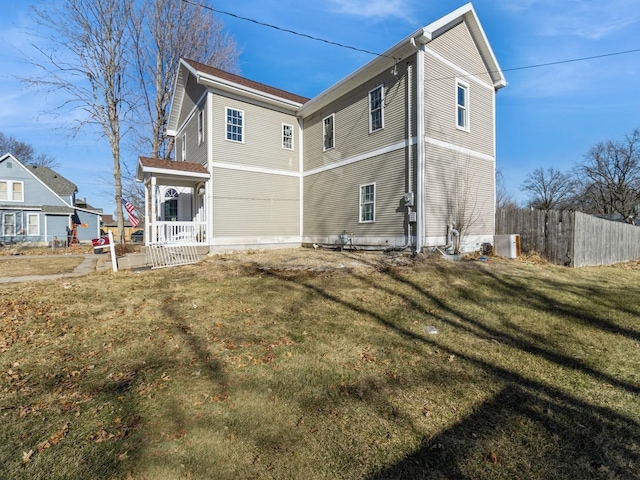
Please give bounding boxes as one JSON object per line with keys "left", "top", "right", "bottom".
{"left": 521, "top": 167, "right": 575, "bottom": 212}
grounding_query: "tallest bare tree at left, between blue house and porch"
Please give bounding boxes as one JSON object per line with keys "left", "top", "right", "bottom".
{"left": 28, "top": 0, "right": 133, "bottom": 239}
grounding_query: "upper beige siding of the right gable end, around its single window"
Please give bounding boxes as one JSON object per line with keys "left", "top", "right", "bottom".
{"left": 424, "top": 23, "right": 495, "bottom": 156}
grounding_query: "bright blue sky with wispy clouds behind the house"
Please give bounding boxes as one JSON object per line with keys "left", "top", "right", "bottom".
{"left": 0, "top": 0, "right": 640, "bottom": 213}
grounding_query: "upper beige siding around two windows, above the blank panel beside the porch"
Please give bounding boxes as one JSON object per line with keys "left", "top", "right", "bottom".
{"left": 211, "top": 94, "right": 299, "bottom": 172}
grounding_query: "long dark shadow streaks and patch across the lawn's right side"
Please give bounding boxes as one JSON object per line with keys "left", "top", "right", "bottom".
{"left": 264, "top": 260, "right": 640, "bottom": 479}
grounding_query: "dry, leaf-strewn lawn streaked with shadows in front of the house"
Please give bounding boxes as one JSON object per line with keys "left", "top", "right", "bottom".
{"left": 0, "top": 251, "right": 640, "bottom": 480}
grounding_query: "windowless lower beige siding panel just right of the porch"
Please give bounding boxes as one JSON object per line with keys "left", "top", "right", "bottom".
{"left": 213, "top": 168, "right": 300, "bottom": 238}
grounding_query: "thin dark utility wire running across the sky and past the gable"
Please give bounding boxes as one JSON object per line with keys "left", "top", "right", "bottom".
{"left": 182, "top": 0, "right": 640, "bottom": 81}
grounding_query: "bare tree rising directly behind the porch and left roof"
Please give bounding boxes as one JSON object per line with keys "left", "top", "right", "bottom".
{"left": 131, "top": 0, "right": 239, "bottom": 158}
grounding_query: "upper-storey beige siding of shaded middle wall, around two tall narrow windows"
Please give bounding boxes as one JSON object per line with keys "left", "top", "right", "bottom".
{"left": 304, "top": 56, "right": 416, "bottom": 170}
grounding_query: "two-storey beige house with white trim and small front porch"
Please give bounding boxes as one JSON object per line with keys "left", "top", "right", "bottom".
{"left": 138, "top": 4, "right": 506, "bottom": 251}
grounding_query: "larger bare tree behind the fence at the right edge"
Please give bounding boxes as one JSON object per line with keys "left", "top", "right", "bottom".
{"left": 576, "top": 129, "right": 640, "bottom": 223}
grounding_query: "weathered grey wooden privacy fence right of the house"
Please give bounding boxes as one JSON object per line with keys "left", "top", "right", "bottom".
{"left": 496, "top": 209, "right": 640, "bottom": 267}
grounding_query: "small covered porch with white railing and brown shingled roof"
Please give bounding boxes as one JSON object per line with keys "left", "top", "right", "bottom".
{"left": 136, "top": 157, "right": 211, "bottom": 246}
